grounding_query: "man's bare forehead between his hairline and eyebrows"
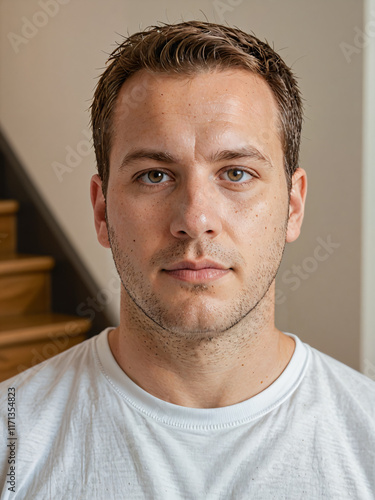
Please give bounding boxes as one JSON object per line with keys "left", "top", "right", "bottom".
{"left": 112, "top": 68, "right": 283, "bottom": 168}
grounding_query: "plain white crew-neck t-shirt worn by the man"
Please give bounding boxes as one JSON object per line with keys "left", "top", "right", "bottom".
{"left": 0, "top": 329, "right": 375, "bottom": 500}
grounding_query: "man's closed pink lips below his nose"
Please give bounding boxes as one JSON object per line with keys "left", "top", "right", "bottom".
{"left": 162, "top": 260, "right": 233, "bottom": 283}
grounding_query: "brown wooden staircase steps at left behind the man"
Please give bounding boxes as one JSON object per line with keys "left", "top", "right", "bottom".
{"left": 0, "top": 200, "right": 91, "bottom": 381}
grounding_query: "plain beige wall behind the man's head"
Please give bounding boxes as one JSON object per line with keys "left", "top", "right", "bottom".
{"left": 0, "top": 0, "right": 363, "bottom": 369}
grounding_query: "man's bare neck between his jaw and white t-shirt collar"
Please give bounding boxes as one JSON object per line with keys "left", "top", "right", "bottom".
{"left": 109, "top": 290, "right": 295, "bottom": 408}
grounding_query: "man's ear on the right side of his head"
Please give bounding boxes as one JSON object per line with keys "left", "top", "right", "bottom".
{"left": 286, "top": 168, "right": 307, "bottom": 243}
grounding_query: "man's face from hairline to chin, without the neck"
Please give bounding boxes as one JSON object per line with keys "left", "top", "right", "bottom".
{"left": 94, "top": 69, "right": 300, "bottom": 337}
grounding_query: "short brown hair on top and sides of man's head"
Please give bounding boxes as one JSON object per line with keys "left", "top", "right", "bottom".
{"left": 91, "top": 21, "right": 302, "bottom": 195}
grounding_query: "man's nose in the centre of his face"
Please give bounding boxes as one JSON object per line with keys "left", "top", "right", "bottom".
{"left": 170, "top": 179, "right": 222, "bottom": 239}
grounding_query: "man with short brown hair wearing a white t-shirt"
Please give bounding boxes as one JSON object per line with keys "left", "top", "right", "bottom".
{"left": 0, "top": 21, "right": 375, "bottom": 500}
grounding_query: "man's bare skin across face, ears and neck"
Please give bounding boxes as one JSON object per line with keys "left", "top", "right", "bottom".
{"left": 91, "top": 69, "right": 307, "bottom": 408}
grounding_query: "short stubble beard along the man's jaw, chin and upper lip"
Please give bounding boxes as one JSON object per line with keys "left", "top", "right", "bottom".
{"left": 106, "top": 209, "right": 288, "bottom": 341}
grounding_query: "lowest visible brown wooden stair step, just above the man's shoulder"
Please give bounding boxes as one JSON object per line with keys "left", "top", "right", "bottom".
{"left": 0, "top": 313, "right": 91, "bottom": 381}
